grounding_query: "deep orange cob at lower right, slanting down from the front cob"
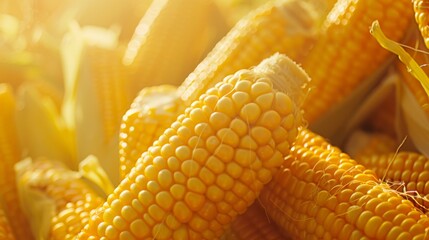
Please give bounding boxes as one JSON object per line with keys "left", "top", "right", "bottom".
{"left": 260, "top": 131, "right": 429, "bottom": 239}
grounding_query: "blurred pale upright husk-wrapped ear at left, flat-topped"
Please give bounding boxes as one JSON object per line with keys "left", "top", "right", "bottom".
{"left": 62, "top": 25, "right": 131, "bottom": 184}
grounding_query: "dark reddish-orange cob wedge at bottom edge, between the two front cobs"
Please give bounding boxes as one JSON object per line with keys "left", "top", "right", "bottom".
{"left": 222, "top": 202, "right": 289, "bottom": 240}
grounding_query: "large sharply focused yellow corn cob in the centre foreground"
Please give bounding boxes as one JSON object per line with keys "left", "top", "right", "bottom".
{"left": 79, "top": 54, "right": 308, "bottom": 239}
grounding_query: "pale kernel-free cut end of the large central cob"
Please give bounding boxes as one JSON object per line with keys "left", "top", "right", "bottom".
{"left": 254, "top": 53, "right": 311, "bottom": 106}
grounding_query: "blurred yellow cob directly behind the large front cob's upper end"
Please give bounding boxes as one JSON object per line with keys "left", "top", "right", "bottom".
{"left": 179, "top": 0, "right": 318, "bottom": 106}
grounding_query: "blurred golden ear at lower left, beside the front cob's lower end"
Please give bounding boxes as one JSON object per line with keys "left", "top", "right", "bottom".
{"left": 17, "top": 158, "right": 102, "bottom": 239}
